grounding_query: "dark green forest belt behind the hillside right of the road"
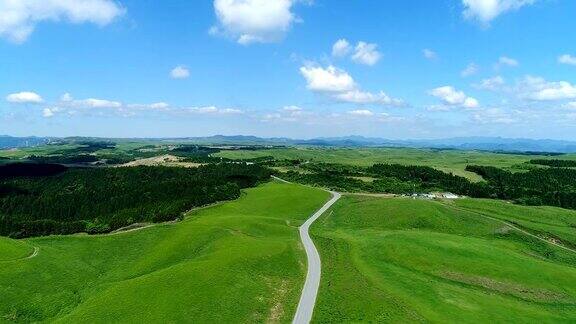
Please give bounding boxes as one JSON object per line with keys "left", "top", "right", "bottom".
{"left": 274, "top": 161, "right": 576, "bottom": 209}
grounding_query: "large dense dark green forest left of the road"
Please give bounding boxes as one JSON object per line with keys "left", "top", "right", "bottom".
{"left": 0, "top": 163, "right": 270, "bottom": 238}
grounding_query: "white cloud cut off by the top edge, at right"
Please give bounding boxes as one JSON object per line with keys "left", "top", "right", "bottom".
{"left": 462, "top": 0, "right": 536, "bottom": 26}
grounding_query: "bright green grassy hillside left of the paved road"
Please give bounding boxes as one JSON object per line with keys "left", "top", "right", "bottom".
{"left": 0, "top": 183, "right": 328, "bottom": 323}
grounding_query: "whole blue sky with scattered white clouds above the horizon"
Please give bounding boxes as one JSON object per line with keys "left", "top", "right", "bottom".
{"left": 0, "top": 0, "right": 576, "bottom": 140}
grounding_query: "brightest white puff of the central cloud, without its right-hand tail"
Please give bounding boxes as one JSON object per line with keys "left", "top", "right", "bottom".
{"left": 300, "top": 65, "right": 356, "bottom": 92}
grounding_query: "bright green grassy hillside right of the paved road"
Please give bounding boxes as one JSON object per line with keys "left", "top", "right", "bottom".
{"left": 313, "top": 197, "right": 576, "bottom": 323}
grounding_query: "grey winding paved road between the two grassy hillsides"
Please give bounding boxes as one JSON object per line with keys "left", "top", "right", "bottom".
{"left": 292, "top": 191, "right": 341, "bottom": 324}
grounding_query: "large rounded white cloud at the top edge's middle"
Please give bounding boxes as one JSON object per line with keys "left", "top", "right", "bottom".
{"left": 211, "top": 0, "right": 299, "bottom": 45}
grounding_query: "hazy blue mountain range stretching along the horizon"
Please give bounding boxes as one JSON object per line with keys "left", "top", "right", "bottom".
{"left": 0, "top": 135, "right": 576, "bottom": 153}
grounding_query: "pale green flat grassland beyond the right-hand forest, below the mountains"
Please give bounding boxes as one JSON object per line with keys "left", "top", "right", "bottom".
{"left": 215, "top": 147, "right": 576, "bottom": 181}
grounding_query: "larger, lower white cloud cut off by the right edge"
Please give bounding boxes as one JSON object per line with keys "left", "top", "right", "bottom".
{"left": 517, "top": 76, "right": 576, "bottom": 101}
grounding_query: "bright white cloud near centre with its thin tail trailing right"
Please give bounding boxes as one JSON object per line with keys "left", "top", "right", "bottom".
{"left": 300, "top": 65, "right": 404, "bottom": 106}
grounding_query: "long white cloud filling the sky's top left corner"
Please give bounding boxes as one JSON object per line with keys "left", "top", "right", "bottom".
{"left": 0, "top": 0, "right": 125, "bottom": 43}
